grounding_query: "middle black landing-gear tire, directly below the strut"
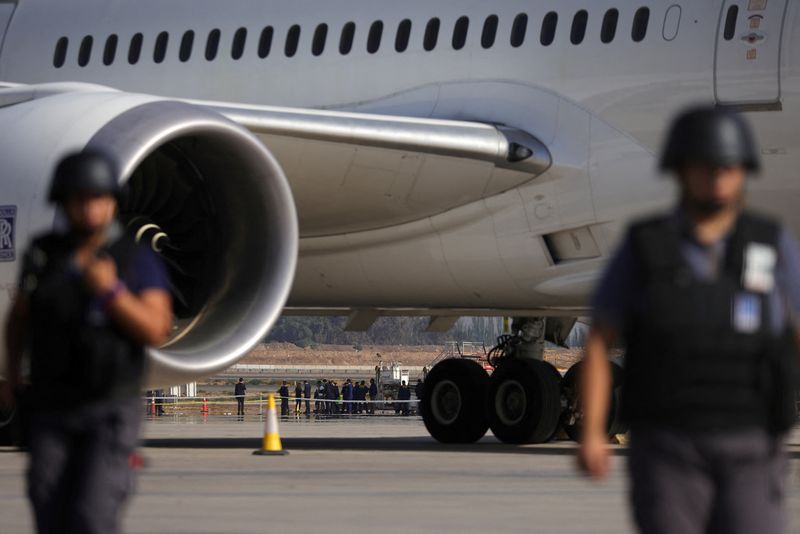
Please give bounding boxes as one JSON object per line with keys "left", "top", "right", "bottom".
{"left": 487, "top": 359, "right": 561, "bottom": 443}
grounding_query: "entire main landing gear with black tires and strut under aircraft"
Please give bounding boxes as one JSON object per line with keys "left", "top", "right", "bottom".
{"left": 420, "top": 317, "right": 626, "bottom": 443}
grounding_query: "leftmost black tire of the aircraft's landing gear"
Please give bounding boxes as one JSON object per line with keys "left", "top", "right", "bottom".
{"left": 419, "top": 358, "right": 489, "bottom": 443}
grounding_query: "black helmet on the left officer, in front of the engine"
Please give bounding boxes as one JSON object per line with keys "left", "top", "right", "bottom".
{"left": 48, "top": 150, "right": 120, "bottom": 203}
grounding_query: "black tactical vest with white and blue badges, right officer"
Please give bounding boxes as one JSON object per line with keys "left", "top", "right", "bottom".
{"left": 622, "top": 213, "right": 796, "bottom": 431}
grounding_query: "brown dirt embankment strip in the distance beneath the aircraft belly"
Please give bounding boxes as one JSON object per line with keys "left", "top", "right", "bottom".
{"left": 240, "top": 343, "right": 582, "bottom": 368}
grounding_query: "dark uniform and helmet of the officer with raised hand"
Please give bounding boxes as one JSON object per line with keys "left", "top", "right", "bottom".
{"left": 14, "top": 150, "right": 168, "bottom": 534}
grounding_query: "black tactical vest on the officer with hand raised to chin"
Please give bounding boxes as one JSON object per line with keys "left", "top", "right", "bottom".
{"left": 22, "top": 234, "right": 145, "bottom": 410}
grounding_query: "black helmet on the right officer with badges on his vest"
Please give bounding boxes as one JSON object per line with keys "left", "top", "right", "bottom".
{"left": 660, "top": 106, "right": 761, "bottom": 176}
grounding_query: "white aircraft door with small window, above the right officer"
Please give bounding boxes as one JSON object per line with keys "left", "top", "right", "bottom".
{"left": 714, "top": 0, "right": 788, "bottom": 107}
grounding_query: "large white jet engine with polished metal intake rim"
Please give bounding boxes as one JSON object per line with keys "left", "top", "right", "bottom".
{"left": 0, "top": 88, "right": 298, "bottom": 385}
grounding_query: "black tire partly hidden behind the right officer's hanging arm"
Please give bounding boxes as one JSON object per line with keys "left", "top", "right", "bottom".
{"left": 561, "top": 361, "right": 628, "bottom": 441}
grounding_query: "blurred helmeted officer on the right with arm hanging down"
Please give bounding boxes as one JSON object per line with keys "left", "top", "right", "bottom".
{"left": 578, "top": 107, "right": 800, "bottom": 534}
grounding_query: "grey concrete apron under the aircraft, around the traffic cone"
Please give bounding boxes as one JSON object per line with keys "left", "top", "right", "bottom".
{"left": 0, "top": 416, "right": 800, "bottom": 534}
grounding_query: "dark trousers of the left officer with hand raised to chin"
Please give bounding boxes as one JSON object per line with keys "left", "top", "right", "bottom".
{"left": 27, "top": 399, "right": 141, "bottom": 534}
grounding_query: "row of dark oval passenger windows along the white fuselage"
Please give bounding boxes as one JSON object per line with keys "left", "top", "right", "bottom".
{"left": 53, "top": 7, "right": 650, "bottom": 68}
